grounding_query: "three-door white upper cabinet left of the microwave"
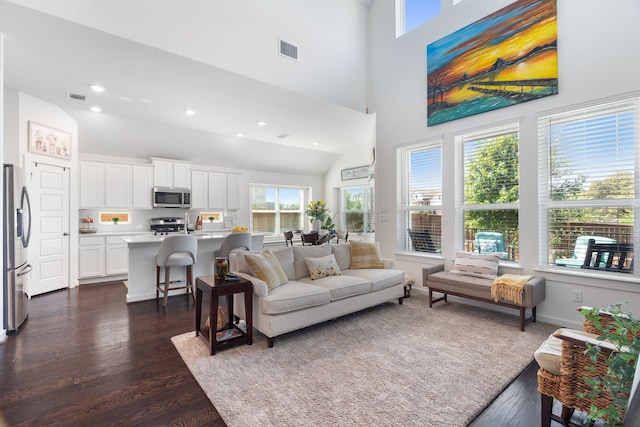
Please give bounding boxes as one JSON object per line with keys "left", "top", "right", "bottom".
{"left": 80, "top": 161, "right": 153, "bottom": 209}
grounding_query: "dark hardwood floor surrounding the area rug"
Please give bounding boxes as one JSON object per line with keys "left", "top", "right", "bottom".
{"left": 0, "top": 282, "right": 596, "bottom": 427}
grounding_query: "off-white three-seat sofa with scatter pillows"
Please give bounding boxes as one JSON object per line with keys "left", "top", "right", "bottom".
{"left": 230, "top": 243, "right": 404, "bottom": 347}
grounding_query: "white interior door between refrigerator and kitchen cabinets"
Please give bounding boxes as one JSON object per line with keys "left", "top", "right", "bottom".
{"left": 25, "top": 163, "right": 69, "bottom": 297}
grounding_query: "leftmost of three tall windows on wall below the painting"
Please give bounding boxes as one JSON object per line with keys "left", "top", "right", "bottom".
{"left": 396, "top": 140, "right": 442, "bottom": 253}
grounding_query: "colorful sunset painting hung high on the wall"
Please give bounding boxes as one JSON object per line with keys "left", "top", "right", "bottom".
{"left": 427, "top": 0, "right": 558, "bottom": 126}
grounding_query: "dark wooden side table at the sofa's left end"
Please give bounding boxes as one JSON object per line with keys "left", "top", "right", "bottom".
{"left": 196, "top": 276, "right": 253, "bottom": 356}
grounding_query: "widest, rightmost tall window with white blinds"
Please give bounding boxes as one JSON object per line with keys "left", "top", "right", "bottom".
{"left": 538, "top": 97, "right": 640, "bottom": 275}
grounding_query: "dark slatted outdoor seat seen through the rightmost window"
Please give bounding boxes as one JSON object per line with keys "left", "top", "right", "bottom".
{"left": 581, "top": 239, "right": 633, "bottom": 273}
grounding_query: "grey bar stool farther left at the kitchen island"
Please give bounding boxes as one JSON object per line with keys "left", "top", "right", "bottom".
{"left": 156, "top": 234, "right": 198, "bottom": 308}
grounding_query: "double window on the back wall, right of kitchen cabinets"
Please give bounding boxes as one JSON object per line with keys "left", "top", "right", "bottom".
{"left": 251, "top": 185, "right": 308, "bottom": 233}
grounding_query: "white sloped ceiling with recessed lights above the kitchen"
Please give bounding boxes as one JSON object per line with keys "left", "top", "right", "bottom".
{"left": 0, "top": 0, "right": 375, "bottom": 175}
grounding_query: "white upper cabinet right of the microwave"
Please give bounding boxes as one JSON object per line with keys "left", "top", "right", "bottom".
{"left": 191, "top": 171, "right": 240, "bottom": 211}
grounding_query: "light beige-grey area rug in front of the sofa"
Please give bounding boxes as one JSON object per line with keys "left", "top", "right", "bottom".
{"left": 172, "top": 292, "right": 556, "bottom": 427}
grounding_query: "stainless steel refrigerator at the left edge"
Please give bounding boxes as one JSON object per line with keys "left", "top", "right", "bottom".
{"left": 2, "top": 164, "right": 31, "bottom": 334}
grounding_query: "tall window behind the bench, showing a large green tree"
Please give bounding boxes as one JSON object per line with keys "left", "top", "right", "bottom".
{"left": 456, "top": 124, "right": 520, "bottom": 261}
